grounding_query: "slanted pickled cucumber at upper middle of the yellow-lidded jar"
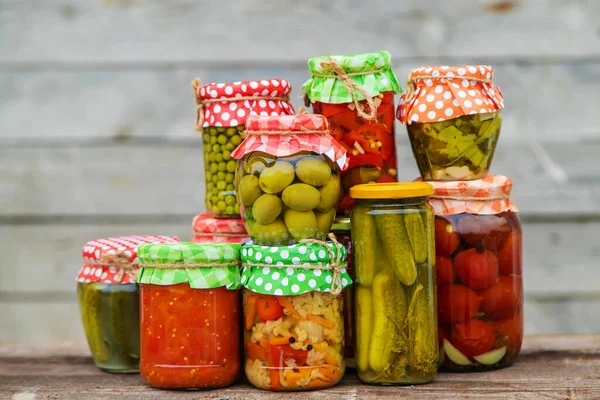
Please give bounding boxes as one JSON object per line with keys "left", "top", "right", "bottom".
{"left": 374, "top": 213, "right": 417, "bottom": 286}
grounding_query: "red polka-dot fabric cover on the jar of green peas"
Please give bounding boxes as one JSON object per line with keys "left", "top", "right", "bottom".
{"left": 196, "top": 79, "right": 295, "bottom": 128}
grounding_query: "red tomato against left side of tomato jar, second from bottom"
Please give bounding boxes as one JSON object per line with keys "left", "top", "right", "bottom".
{"left": 438, "top": 284, "right": 481, "bottom": 324}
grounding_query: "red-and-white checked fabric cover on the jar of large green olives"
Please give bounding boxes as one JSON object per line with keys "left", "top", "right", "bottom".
{"left": 231, "top": 114, "right": 349, "bottom": 170}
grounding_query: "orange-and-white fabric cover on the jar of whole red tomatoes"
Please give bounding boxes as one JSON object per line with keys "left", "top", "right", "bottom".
{"left": 415, "top": 175, "right": 519, "bottom": 215}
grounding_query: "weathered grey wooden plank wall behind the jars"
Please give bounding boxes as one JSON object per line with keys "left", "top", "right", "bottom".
{"left": 0, "top": 0, "right": 600, "bottom": 340}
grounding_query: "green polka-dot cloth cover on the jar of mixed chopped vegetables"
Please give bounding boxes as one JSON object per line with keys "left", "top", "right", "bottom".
{"left": 241, "top": 242, "right": 352, "bottom": 296}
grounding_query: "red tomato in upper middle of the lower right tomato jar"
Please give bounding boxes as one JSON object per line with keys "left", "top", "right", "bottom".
{"left": 454, "top": 248, "right": 498, "bottom": 290}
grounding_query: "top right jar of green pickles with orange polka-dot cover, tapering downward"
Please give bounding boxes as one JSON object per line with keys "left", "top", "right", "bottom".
{"left": 397, "top": 65, "right": 504, "bottom": 181}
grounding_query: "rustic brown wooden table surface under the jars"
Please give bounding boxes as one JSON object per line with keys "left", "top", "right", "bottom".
{"left": 0, "top": 335, "right": 600, "bottom": 400}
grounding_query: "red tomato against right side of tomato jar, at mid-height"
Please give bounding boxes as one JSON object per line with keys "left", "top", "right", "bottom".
{"left": 479, "top": 275, "right": 523, "bottom": 319}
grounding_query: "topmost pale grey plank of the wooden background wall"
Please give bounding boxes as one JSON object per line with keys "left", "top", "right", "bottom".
{"left": 0, "top": 0, "right": 600, "bottom": 64}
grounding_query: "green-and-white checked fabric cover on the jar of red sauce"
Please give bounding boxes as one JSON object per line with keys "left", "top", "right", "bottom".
{"left": 138, "top": 242, "right": 240, "bottom": 290}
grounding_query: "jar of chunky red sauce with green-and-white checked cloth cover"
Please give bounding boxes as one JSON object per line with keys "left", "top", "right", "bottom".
{"left": 138, "top": 242, "right": 241, "bottom": 389}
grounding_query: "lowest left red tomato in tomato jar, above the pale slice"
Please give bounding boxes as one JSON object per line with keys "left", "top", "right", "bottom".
{"left": 452, "top": 319, "right": 496, "bottom": 357}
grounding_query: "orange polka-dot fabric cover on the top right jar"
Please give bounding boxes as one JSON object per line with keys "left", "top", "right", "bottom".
{"left": 396, "top": 65, "right": 504, "bottom": 125}
